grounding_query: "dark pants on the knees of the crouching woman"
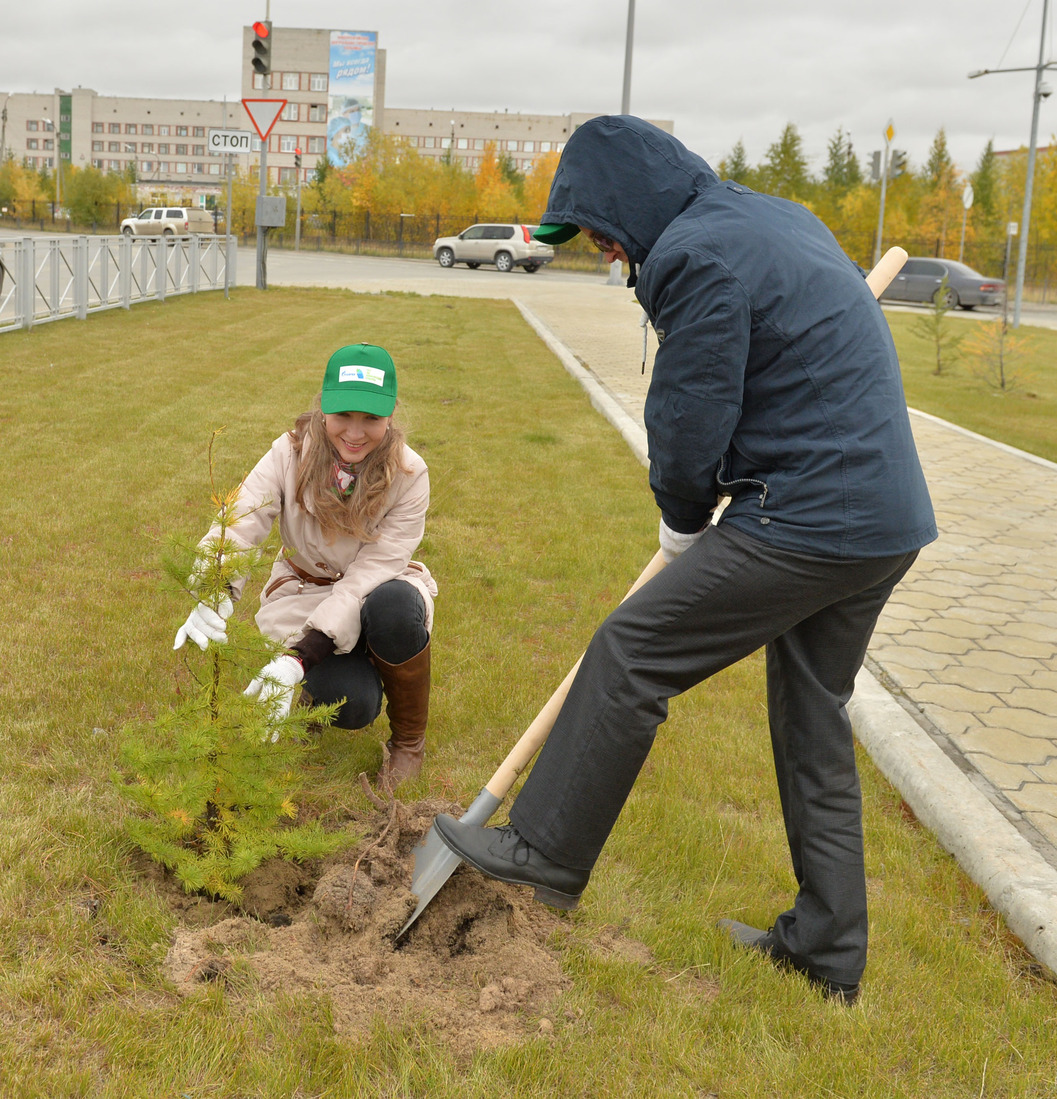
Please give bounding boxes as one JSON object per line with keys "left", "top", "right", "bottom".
{"left": 304, "top": 580, "right": 430, "bottom": 729}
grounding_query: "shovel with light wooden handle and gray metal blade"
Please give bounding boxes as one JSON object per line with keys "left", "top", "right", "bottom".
{"left": 397, "top": 246, "right": 906, "bottom": 939}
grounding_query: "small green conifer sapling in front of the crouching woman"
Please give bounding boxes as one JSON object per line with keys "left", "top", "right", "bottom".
{"left": 115, "top": 433, "right": 356, "bottom": 901}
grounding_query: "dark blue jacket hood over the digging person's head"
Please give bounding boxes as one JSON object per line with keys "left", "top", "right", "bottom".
{"left": 541, "top": 114, "right": 720, "bottom": 270}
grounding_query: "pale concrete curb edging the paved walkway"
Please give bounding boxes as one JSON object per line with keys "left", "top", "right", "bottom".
{"left": 513, "top": 298, "right": 1057, "bottom": 974}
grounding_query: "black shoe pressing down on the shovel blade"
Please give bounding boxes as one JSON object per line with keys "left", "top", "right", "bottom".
{"left": 433, "top": 813, "right": 591, "bottom": 909}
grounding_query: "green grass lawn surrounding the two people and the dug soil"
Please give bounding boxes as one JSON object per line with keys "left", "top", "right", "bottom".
{"left": 0, "top": 289, "right": 1057, "bottom": 1099}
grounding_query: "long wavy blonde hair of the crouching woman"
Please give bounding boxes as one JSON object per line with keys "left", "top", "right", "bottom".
{"left": 290, "top": 397, "right": 410, "bottom": 542}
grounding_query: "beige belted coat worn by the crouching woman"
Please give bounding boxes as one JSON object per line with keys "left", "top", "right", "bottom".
{"left": 207, "top": 434, "right": 437, "bottom": 653}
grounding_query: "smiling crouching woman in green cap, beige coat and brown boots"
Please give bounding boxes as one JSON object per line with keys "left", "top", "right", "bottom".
{"left": 175, "top": 344, "right": 437, "bottom": 786}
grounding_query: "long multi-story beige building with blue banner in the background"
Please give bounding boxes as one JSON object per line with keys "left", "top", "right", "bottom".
{"left": 0, "top": 26, "right": 672, "bottom": 206}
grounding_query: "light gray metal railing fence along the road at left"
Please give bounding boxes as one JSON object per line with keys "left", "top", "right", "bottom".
{"left": 0, "top": 235, "right": 237, "bottom": 333}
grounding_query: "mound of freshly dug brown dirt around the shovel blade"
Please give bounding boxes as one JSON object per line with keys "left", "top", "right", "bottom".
{"left": 155, "top": 801, "right": 568, "bottom": 1054}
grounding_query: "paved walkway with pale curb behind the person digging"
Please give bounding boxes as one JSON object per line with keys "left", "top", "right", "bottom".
{"left": 254, "top": 254, "right": 1057, "bottom": 972}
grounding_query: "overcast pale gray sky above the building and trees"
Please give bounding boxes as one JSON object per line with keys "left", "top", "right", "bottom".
{"left": 0, "top": 0, "right": 1057, "bottom": 171}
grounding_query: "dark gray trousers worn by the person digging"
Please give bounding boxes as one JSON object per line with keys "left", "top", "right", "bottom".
{"left": 510, "top": 524, "right": 917, "bottom": 984}
